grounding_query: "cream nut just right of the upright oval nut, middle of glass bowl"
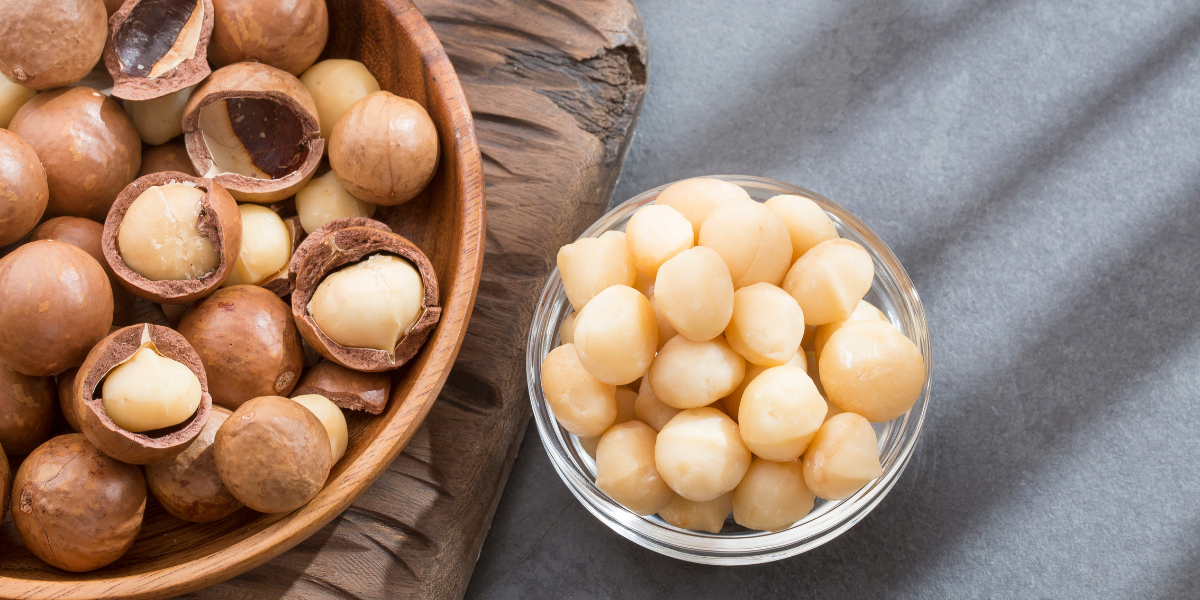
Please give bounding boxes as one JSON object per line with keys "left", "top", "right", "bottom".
{"left": 725, "top": 283, "right": 804, "bottom": 367}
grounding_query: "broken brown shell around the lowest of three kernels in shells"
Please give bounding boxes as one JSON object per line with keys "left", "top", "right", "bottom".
{"left": 73, "top": 323, "right": 212, "bottom": 464}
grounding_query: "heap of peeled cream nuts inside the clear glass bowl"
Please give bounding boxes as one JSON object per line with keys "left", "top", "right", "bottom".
{"left": 541, "top": 179, "right": 925, "bottom": 533}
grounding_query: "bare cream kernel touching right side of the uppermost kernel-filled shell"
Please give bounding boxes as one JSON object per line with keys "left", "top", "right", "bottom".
{"left": 221, "top": 204, "right": 292, "bottom": 286}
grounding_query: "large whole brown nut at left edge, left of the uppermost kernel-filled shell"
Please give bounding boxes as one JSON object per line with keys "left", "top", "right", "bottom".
{"left": 0, "top": 240, "right": 113, "bottom": 377}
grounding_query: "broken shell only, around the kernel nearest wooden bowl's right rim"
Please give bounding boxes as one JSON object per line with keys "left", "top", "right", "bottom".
{"left": 292, "top": 223, "right": 442, "bottom": 372}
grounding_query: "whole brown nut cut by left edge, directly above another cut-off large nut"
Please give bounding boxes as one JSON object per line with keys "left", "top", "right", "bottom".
{"left": 0, "top": 128, "right": 50, "bottom": 246}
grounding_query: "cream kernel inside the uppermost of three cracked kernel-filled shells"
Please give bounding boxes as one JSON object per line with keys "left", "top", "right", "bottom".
{"left": 116, "top": 182, "right": 221, "bottom": 281}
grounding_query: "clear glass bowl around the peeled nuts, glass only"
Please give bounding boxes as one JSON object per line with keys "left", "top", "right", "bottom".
{"left": 526, "top": 175, "right": 932, "bottom": 564}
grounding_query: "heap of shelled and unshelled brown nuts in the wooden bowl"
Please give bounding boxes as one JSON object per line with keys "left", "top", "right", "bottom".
{"left": 0, "top": 0, "right": 442, "bottom": 571}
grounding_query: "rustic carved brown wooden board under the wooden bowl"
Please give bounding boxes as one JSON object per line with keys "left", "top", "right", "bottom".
{"left": 182, "top": 0, "right": 647, "bottom": 599}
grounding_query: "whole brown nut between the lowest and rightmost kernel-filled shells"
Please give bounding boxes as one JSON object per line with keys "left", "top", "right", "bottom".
{"left": 178, "top": 286, "right": 304, "bottom": 410}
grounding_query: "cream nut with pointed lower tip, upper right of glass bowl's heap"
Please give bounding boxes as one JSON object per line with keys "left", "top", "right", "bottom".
{"left": 782, "top": 239, "right": 875, "bottom": 325}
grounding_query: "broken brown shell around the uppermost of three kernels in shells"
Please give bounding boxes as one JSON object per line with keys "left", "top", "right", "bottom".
{"left": 102, "top": 172, "right": 241, "bottom": 304}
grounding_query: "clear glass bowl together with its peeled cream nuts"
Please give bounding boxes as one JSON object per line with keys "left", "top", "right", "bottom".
{"left": 527, "top": 175, "right": 932, "bottom": 564}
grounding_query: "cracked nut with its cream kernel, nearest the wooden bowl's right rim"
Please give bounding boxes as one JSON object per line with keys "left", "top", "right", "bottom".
{"left": 292, "top": 223, "right": 442, "bottom": 372}
